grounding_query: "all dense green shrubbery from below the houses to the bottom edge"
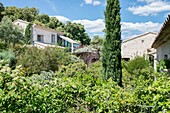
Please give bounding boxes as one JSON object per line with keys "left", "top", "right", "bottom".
{"left": 0, "top": 47, "right": 170, "bottom": 113}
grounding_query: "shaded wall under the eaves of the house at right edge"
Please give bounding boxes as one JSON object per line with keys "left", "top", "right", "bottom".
{"left": 157, "top": 40, "right": 170, "bottom": 60}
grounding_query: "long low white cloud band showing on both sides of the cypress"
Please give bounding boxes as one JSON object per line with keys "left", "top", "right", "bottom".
{"left": 50, "top": 15, "right": 162, "bottom": 40}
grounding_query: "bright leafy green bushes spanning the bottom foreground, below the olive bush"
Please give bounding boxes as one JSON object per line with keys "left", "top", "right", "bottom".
{"left": 0, "top": 61, "right": 170, "bottom": 113}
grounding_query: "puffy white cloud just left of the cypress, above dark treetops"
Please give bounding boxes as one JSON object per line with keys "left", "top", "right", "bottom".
{"left": 72, "top": 19, "right": 105, "bottom": 33}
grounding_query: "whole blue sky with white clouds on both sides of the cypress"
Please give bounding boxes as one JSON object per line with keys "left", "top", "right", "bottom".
{"left": 0, "top": 0, "right": 170, "bottom": 39}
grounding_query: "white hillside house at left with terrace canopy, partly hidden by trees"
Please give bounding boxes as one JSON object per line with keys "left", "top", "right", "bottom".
{"left": 14, "top": 19, "right": 79, "bottom": 52}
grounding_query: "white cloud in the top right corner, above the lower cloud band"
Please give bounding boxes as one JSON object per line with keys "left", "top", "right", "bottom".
{"left": 128, "top": 0, "right": 170, "bottom": 16}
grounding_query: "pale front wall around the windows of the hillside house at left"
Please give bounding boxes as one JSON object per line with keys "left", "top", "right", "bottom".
{"left": 33, "top": 27, "right": 57, "bottom": 44}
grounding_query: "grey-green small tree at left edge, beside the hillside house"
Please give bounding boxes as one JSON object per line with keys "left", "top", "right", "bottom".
{"left": 0, "top": 16, "right": 24, "bottom": 46}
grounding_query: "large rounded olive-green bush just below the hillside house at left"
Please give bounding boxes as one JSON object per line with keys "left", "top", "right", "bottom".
{"left": 17, "top": 47, "right": 68, "bottom": 75}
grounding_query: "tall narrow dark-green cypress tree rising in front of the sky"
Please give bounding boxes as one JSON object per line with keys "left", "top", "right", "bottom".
{"left": 102, "top": 0, "right": 122, "bottom": 86}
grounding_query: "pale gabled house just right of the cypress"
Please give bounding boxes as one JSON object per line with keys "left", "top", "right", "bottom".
{"left": 121, "top": 32, "right": 156, "bottom": 60}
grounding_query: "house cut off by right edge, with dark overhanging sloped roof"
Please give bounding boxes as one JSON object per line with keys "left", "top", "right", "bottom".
{"left": 152, "top": 15, "right": 170, "bottom": 67}
